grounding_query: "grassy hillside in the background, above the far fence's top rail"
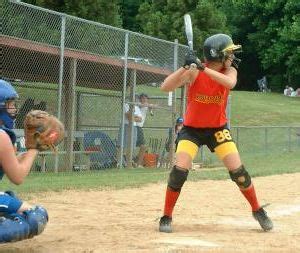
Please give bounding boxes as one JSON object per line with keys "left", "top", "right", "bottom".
{"left": 17, "top": 83, "right": 300, "bottom": 127}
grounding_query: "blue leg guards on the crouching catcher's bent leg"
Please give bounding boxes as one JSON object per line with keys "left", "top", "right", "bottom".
{"left": 0, "top": 206, "right": 48, "bottom": 243}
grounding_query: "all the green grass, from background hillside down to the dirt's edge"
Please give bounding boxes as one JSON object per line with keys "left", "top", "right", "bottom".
{"left": 7, "top": 84, "right": 300, "bottom": 195}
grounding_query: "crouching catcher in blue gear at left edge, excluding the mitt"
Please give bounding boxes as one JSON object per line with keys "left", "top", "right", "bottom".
{"left": 0, "top": 80, "right": 48, "bottom": 243}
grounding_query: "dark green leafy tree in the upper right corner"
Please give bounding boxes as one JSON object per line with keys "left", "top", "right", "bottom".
{"left": 234, "top": 0, "right": 300, "bottom": 91}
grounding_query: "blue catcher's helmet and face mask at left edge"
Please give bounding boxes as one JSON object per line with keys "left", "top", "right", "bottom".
{"left": 0, "top": 79, "right": 19, "bottom": 129}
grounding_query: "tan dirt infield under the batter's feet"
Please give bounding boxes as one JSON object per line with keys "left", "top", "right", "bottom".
{"left": 0, "top": 173, "right": 300, "bottom": 253}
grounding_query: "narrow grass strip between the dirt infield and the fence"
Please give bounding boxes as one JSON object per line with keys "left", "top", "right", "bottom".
{"left": 2, "top": 148, "right": 300, "bottom": 194}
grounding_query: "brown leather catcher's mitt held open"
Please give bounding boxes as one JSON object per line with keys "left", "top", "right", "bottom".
{"left": 24, "top": 110, "right": 64, "bottom": 151}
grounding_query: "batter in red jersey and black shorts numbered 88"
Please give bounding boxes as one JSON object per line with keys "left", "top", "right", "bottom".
{"left": 159, "top": 34, "right": 273, "bottom": 233}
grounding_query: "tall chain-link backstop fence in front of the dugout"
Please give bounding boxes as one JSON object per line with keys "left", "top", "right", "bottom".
{"left": 0, "top": 1, "right": 187, "bottom": 171}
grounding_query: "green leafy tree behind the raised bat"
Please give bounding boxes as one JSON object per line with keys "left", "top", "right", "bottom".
{"left": 137, "top": 0, "right": 228, "bottom": 52}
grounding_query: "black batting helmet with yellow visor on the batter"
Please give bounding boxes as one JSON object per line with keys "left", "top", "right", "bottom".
{"left": 203, "top": 33, "right": 242, "bottom": 68}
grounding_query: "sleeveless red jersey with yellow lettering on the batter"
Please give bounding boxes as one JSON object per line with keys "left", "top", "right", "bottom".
{"left": 184, "top": 70, "right": 230, "bottom": 128}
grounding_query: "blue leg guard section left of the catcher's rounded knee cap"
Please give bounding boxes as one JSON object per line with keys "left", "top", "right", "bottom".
{"left": 0, "top": 213, "right": 30, "bottom": 243}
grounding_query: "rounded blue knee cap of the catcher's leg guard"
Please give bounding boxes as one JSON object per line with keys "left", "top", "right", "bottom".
{"left": 23, "top": 206, "right": 49, "bottom": 237}
